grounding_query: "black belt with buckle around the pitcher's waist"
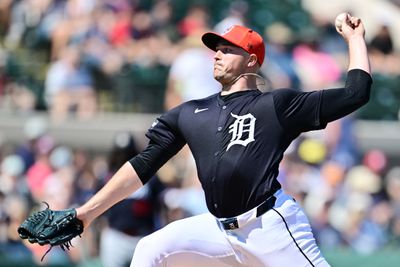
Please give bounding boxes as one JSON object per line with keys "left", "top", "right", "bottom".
{"left": 218, "top": 195, "right": 276, "bottom": 230}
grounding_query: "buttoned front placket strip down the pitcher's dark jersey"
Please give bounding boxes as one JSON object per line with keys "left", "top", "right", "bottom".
{"left": 211, "top": 104, "right": 228, "bottom": 218}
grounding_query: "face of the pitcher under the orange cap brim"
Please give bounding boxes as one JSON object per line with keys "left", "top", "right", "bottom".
{"left": 214, "top": 43, "right": 249, "bottom": 85}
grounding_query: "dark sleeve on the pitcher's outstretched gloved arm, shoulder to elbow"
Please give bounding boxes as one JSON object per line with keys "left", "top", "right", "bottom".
{"left": 129, "top": 106, "right": 186, "bottom": 184}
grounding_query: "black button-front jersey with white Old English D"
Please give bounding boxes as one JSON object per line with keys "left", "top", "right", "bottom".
{"left": 131, "top": 69, "right": 369, "bottom": 220}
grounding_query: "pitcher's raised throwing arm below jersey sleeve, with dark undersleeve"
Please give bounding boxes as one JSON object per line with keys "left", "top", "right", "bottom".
{"left": 320, "top": 15, "right": 372, "bottom": 123}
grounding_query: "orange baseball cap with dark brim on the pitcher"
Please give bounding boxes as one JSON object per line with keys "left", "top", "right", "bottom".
{"left": 201, "top": 25, "right": 265, "bottom": 66}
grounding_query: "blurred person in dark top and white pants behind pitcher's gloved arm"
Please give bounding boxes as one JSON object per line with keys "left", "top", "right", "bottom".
{"left": 100, "top": 132, "right": 164, "bottom": 267}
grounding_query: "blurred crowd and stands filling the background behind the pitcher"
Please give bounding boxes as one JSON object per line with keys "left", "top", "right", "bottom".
{"left": 0, "top": 0, "right": 400, "bottom": 267}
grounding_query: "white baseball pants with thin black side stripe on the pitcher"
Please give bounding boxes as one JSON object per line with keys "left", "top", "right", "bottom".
{"left": 131, "top": 190, "right": 329, "bottom": 267}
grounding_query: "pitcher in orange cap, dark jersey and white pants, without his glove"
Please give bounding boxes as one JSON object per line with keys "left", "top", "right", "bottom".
{"left": 77, "top": 15, "right": 372, "bottom": 267}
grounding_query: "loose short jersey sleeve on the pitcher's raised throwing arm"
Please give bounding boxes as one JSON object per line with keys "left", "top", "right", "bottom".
{"left": 272, "top": 89, "right": 326, "bottom": 135}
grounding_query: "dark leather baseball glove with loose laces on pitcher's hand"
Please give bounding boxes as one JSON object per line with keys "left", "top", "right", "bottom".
{"left": 18, "top": 203, "right": 83, "bottom": 260}
